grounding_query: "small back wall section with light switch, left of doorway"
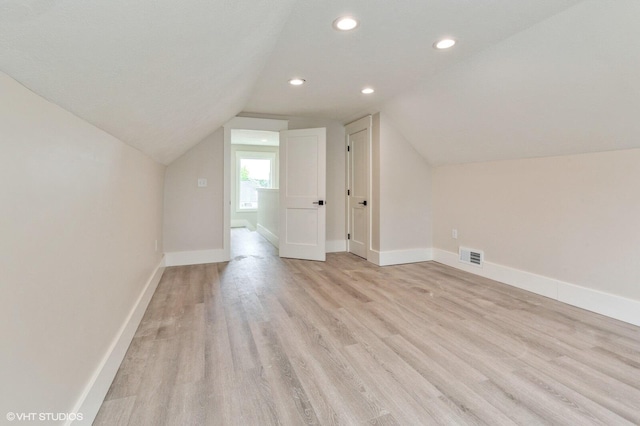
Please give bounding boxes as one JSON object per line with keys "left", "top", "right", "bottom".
{"left": 164, "top": 128, "right": 224, "bottom": 253}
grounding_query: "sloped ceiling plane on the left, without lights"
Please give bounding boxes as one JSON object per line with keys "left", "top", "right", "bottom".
{"left": 0, "top": 0, "right": 294, "bottom": 164}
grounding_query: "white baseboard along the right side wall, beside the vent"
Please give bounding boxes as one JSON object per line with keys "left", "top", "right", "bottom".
{"left": 433, "top": 249, "right": 640, "bottom": 326}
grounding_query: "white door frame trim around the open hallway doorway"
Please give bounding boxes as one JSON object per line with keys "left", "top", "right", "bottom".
{"left": 222, "top": 117, "right": 289, "bottom": 260}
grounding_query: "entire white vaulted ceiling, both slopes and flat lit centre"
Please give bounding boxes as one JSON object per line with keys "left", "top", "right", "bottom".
{"left": 0, "top": 0, "right": 640, "bottom": 164}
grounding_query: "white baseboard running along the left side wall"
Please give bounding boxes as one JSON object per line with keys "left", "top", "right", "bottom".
{"left": 71, "top": 258, "right": 165, "bottom": 426}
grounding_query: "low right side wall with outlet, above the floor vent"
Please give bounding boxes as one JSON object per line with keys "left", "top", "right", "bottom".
{"left": 433, "top": 149, "right": 640, "bottom": 301}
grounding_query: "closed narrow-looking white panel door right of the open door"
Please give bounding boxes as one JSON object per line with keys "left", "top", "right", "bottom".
{"left": 347, "top": 120, "right": 370, "bottom": 259}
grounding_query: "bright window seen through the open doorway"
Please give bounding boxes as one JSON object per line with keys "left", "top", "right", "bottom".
{"left": 236, "top": 151, "right": 277, "bottom": 211}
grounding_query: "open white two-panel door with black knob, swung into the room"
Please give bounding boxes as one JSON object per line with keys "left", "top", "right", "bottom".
{"left": 279, "top": 128, "right": 327, "bottom": 261}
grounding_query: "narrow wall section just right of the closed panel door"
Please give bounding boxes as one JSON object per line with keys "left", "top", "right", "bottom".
{"left": 372, "top": 113, "right": 432, "bottom": 264}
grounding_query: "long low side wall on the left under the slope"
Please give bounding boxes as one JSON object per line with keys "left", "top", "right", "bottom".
{"left": 0, "top": 73, "right": 164, "bottom": 420}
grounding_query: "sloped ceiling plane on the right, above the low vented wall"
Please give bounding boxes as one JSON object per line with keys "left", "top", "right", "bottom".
{"left": 382, "top": 0, "right": 640, "bottom": 165}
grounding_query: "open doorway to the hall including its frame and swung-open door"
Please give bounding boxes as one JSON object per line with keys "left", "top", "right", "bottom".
{"left": 223, "top": 117, "right": 326, "bottom": 260}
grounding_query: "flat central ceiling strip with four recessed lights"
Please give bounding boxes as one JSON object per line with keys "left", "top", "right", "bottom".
{"left": 244, "top": 0, "right": 579, "bottom": 121}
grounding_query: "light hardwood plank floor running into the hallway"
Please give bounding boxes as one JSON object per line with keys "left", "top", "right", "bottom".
{"left": 94, "top": 230, "right": 640, "bottom": 425}
